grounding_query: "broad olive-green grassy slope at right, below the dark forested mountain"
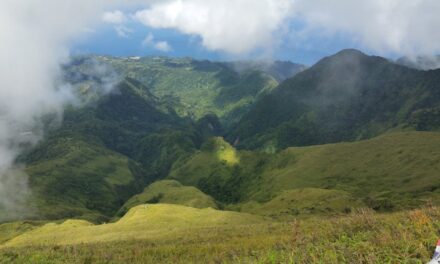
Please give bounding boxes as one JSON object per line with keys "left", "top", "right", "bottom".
{"left": 169, "top": 132, "right": 440, "bottom": 215}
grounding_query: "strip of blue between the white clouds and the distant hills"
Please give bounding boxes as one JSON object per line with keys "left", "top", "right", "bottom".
{"left": 71, "top": 21, "right": 374, "bottom": 65}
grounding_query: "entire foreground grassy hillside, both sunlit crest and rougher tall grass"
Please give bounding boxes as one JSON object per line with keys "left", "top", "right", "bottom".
{"left": 0, "top": 205, "right": 440, "bottom": 263}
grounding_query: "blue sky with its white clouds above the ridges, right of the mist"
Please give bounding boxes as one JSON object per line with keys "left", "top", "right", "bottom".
{"left": 70, "top": 0, "right": 440, "bottom": 65}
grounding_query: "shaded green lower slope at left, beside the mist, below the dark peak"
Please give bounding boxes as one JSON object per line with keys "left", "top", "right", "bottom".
{"left": 26, "top": 138, "right": 143, "bottom": 220}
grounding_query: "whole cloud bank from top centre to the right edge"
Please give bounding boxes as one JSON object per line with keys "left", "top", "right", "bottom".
{"left": 134, "top": 0, "right": 440, "bottom": 55}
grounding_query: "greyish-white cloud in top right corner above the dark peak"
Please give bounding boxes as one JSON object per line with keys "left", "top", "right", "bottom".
{"left": 295, "top": 0, "right": 440, "bottom": 55}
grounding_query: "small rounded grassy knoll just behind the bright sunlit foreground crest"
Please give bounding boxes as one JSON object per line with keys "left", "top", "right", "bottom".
{"left": 117, "top": 180, "right": 217, "bottom": 216}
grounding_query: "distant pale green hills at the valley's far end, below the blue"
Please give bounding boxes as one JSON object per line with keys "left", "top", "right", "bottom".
{"left": 65, "top": 56, "right": 303, "bottom": 126}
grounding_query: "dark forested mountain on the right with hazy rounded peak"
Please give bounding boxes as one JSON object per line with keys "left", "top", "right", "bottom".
{"left": 228, "top": 50, "right": 440, "bottom": 151}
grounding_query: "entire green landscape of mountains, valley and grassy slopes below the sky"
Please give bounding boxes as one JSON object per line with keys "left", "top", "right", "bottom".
{"left": 4, "top": 50, "right": 440, "bottom": 263}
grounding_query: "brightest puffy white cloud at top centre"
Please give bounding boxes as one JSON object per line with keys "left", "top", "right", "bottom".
{"left": 134, "top": 0, "right": 293, "bottom": 54}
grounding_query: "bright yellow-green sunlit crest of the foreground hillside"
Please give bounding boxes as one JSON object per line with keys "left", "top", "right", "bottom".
{"left": 0, "top": 204, "right": 266, "bottom": 247}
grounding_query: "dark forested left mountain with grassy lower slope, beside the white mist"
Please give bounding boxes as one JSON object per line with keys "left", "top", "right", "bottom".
{"left": 22, "top": 79, "right": 202, "bottom": 221}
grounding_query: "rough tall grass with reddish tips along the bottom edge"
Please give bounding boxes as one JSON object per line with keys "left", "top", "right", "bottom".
{"left": 0, "top": 207, "right": 440, "bottom": 263}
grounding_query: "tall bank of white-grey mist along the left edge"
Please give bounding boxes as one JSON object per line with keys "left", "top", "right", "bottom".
{"left": 0, "top": 0, "right": 132, "bottom": 221}
